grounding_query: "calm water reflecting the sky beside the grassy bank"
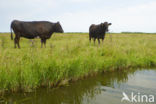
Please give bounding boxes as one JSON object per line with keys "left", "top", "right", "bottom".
{"left": 1, "top": 70, "right": 156, "bottom": 104}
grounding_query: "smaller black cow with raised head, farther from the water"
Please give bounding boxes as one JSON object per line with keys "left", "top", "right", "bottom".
{"left": 89, "top": 22, "right": 111, "bottom": 44}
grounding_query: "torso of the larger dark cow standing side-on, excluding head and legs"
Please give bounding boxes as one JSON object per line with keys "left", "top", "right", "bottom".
{"left": 11, "top": 20, "right": 54, "bottom": 39}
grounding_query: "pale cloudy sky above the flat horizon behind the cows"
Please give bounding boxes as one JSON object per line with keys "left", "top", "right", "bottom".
{"left": 0, "top": 0, "right": 156, "bottom": 33}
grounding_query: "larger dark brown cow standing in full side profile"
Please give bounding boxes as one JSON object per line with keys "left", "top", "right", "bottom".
{"left": 10, "top": 20, "right": 63, "bottom": 48}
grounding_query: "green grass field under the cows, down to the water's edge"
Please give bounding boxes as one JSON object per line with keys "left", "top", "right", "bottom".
{"left": 0, "top": 33, "right": 156, "bottom": 93}
